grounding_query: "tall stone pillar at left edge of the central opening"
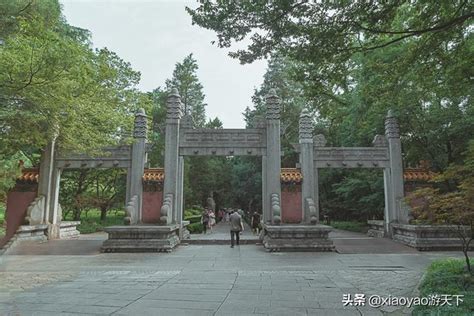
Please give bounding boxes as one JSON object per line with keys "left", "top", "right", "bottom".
{"left": 160, "top": 88, "right": 182, "bottom": 224}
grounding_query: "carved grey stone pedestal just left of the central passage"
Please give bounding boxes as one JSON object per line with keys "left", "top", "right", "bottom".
{"left": 101, "top": 225, "right": 179, "bottom": 252}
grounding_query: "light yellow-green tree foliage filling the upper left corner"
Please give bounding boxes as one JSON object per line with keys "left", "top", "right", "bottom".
{"left": 0, "top": 0, "right": 149, "bottom": 155}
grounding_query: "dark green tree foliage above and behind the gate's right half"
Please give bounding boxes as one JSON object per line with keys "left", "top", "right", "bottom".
{"left": 192, "top": 1, "right": 474, "bottom": 220}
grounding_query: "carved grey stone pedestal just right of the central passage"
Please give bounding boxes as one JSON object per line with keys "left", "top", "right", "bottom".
{"left": 261, "top": 225, "right": 334, "bottom": 251}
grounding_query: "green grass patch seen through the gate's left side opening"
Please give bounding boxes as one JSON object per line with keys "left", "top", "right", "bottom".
{"left": 63, "top": 210, "right": 125, "bottom": 234}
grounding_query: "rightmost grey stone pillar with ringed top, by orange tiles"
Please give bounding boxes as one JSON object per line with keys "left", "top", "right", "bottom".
{"left": 385, "top": 111, "right": 408, "bottom": 223}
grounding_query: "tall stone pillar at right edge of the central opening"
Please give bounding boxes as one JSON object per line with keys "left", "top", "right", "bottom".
{"left": 264, "top": 89, "right": 281, "bottom": 224}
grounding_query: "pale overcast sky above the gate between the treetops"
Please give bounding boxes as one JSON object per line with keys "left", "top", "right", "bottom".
{"left": 60, "top": 0, "right": 267, "bottom": 128}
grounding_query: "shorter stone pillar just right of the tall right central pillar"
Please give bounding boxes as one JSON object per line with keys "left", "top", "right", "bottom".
{"left": 299, "top": 109, "right": 319, "bottom": 224}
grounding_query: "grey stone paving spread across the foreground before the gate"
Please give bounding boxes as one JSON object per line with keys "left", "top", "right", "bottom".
{"left": 0, "top": 225, "right": 468, "bottom": 315}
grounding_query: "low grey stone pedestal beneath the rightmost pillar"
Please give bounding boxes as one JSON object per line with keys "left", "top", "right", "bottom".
{"left": 391, "top": 224, "right": 474, "bottom": 251}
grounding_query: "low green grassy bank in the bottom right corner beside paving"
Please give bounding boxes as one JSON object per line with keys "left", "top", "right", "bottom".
{"left": 413, "top": 258, "right": 474, "bottom": 315}
